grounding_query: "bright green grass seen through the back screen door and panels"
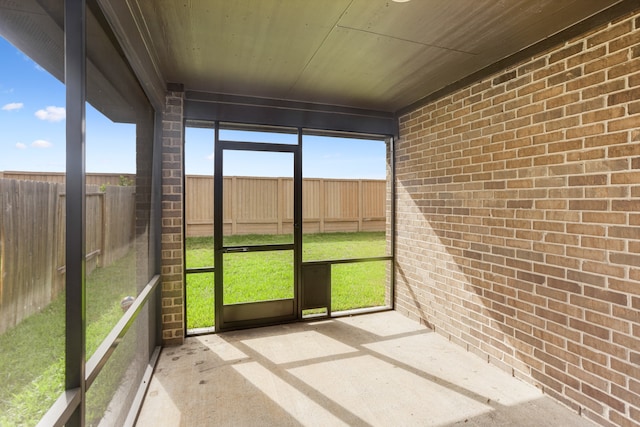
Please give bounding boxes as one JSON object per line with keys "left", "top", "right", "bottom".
{"left": 186, "top": 232, "right": 387, "bottom": 329}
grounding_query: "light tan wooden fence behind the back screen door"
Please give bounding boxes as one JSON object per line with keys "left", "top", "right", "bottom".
{"left": 185, "top": 175, "right": 387, "bottom": 237}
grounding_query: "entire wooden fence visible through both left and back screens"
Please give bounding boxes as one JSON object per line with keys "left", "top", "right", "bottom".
{"left": 0, "top": 172, "right": 387, "bottom": 333}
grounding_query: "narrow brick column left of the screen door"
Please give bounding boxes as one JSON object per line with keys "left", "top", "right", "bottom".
{"left": 162, "top": 88, "right": 185, "bottom": 345}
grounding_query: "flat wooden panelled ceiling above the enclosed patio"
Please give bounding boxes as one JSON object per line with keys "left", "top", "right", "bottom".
{"left": 132, "top": 0, "right": 619, "bottom": 111}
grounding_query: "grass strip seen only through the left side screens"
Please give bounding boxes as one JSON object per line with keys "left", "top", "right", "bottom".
{"left": 0, "top": 252, "right": 136, "bottom": 427}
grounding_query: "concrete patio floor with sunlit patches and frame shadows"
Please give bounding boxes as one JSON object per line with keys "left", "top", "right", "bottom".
{"left": 137, "top": 312, "right": 594, "bottom": 427}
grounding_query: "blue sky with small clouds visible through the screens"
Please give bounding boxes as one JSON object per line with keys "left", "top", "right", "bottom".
{"left": 0, "top": 37, "right": 385, "bottom": 179}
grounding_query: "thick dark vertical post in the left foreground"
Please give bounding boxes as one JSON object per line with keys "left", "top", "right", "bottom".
{"left": 64, "top": 0, "right": 87, "bottom": 426}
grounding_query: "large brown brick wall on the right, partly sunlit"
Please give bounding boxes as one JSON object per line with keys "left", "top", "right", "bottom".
{"left": 396, "top": 10, "right": 640, "bottom": 426}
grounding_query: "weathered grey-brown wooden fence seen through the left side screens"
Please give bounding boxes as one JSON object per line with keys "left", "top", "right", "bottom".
{"left": 0, "top": 178, "right": 135, "bottom": 333}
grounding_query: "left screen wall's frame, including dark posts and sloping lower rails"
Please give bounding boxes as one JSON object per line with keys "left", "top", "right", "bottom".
{"left": 38, "top": 0, "right": 162, "bottom": 427}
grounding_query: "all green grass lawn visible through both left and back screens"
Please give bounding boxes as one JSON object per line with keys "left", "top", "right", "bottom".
{"left": 0, "top": 233, "right": 386, "bottom": 427}
